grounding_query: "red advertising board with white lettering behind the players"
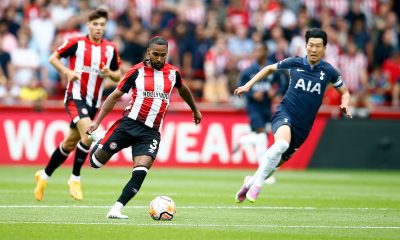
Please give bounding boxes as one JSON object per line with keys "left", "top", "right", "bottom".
{"left": 0, "top": 110, "right": 326, "bottom": 169}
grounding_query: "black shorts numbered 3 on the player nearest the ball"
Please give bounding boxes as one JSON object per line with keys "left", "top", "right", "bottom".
{"left": 99, "top": 117, "right": 161, "bottom": 160}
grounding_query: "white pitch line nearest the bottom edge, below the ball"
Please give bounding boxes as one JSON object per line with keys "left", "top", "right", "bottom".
{"left": 0, "top": 219, "right": 400, "bottom": 229}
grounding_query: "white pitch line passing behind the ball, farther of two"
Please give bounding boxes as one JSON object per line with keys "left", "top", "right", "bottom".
{"left": 0, "top": 205, "right": 400, "bottom": 211}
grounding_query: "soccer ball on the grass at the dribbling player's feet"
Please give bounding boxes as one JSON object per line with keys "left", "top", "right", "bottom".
{"left": 150, "top": 196, "right": 176, "bottom": 220}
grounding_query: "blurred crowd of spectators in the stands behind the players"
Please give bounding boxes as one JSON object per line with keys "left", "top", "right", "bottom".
{"left": 0, "top": 0, "right": 400, "bottom": 108}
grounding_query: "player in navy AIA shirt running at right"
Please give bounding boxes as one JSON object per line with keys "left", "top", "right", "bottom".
{"left": 235, "top": 28, "right": 351, "bottom": 202}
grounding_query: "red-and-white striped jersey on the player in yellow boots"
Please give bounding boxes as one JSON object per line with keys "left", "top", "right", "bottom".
{"left": 57, "top": 36, "right": 121, "bottom": 108}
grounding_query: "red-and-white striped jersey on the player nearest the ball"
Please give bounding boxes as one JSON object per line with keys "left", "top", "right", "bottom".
{"left": 118, "top": 60, "right": 183, "bottom": 130}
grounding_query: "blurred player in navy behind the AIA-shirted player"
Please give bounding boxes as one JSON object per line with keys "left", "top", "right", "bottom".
{"left": 233, "top": 43, "right": 287, "bottom": 184}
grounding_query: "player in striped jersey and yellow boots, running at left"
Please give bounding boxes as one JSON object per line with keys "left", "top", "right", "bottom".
{"left": 34, "top": 8, "right": 121, "bottom": 201}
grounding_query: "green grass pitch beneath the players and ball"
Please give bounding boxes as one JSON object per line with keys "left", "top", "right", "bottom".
{"left": 0, "top": 166, "right": 400, "bottom": 240}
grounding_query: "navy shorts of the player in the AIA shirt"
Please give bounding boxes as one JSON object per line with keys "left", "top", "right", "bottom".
{"left": 272, "top": 111, "right": 309, "bottom": 161}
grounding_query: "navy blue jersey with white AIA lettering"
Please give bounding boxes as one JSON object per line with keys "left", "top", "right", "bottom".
{"left": 277, "top": 57, "right": 344, "bottom": 132}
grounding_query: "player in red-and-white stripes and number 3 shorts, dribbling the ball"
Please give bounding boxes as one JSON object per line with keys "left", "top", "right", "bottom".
{"left": 87, "top": 36, "right": 202, "bottom": 219}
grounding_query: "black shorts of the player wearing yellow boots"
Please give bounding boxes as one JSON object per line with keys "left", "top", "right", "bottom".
{"left": 64, "top": 98, "right": 98, "bottom": 128}
